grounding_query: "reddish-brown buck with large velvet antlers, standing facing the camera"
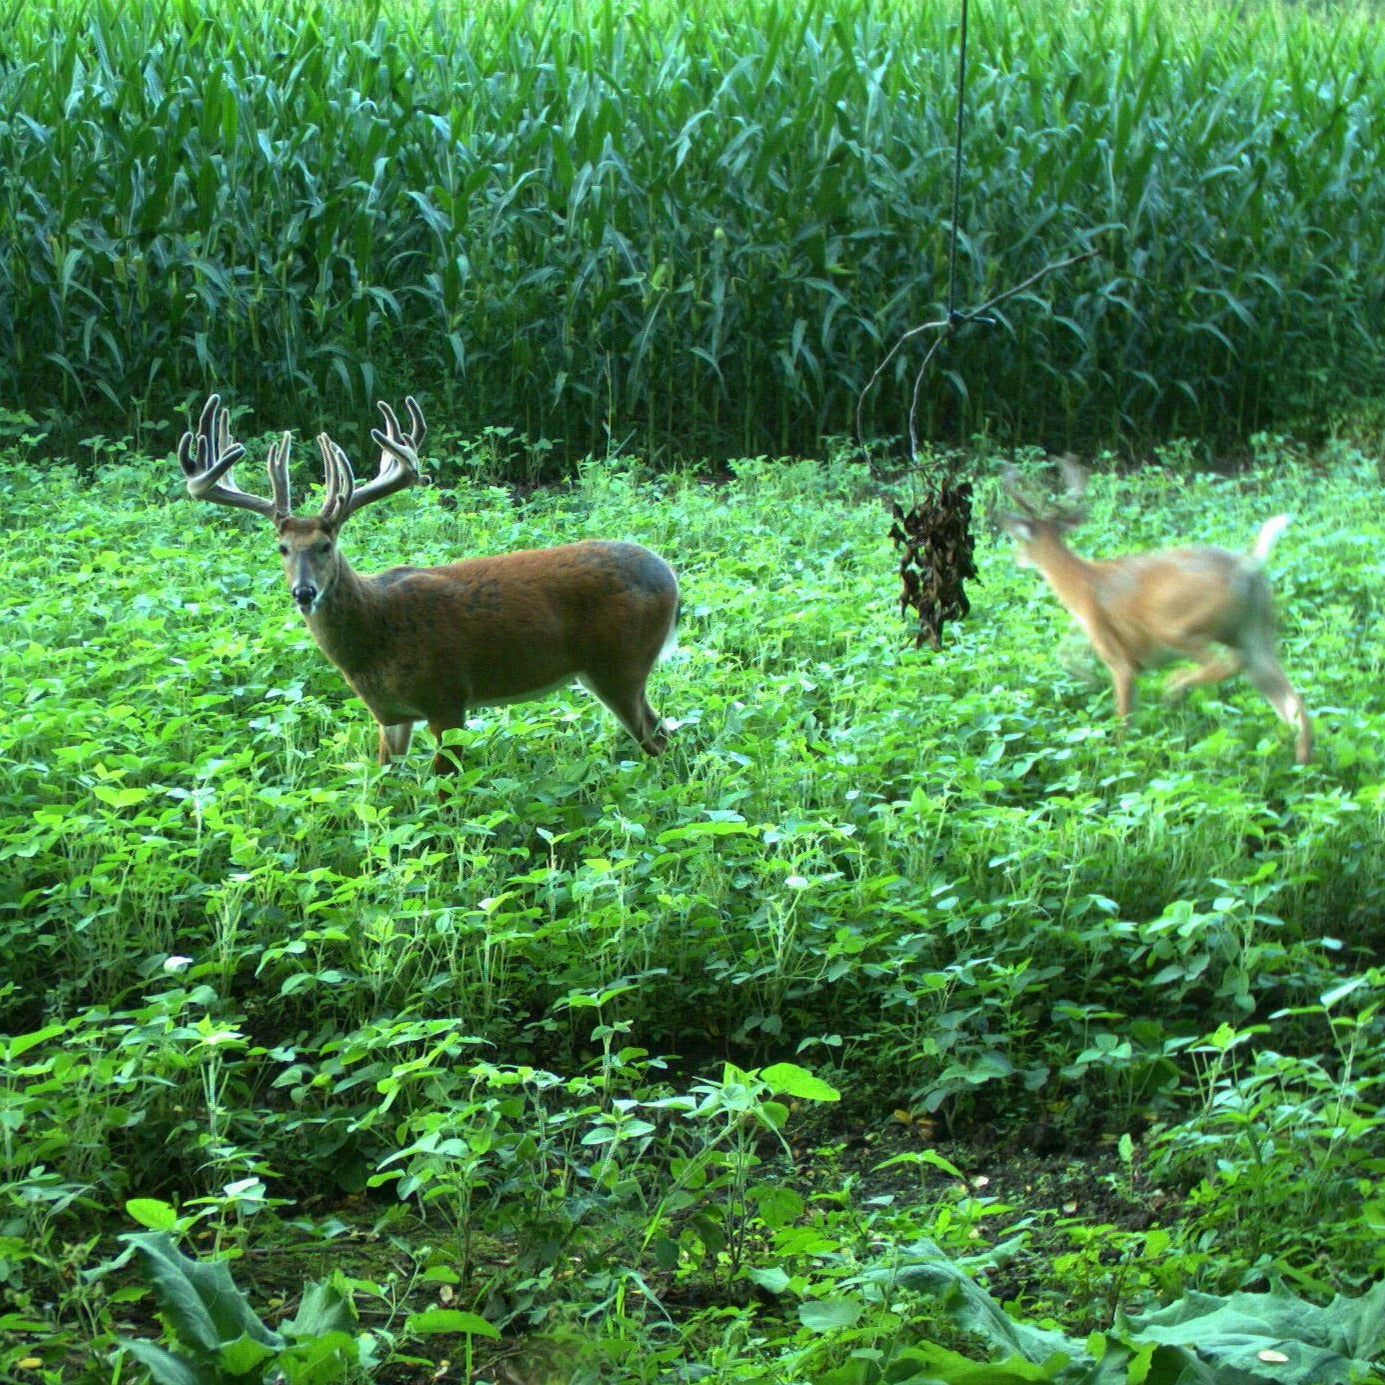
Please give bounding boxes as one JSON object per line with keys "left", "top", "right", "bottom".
{"left": 177, "top": 395, "right": 679, "bottom": 773}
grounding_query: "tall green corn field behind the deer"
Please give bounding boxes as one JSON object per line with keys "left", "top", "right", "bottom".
{"left": 0, "top": 0, "right": 1385, "bottom": 456}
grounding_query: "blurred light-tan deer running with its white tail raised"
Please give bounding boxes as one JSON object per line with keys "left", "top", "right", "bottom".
{"left": 1003, "top": 461, "right": 1313, "bottom": 765}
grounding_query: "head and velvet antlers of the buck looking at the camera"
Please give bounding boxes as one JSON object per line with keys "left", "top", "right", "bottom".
{"left": 177, "top": 395, "right": 428, "bottom": 616}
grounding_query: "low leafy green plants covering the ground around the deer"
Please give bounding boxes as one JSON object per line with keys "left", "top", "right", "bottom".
{"left": 0, "top": 417, "right": 1385, "bottom": 1385}
